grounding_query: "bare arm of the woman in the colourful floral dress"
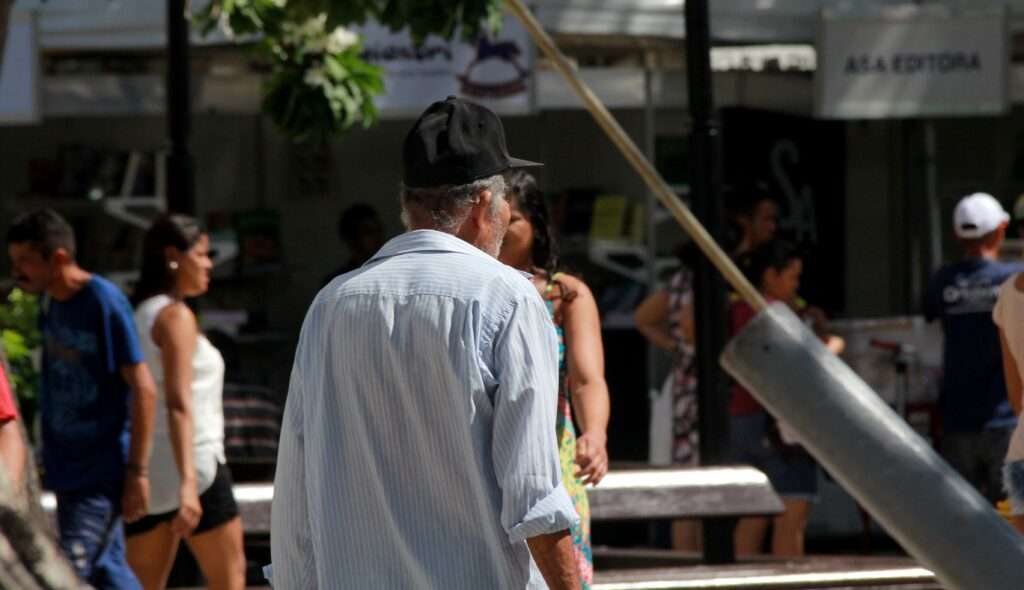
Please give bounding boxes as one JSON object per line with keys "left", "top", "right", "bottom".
{"left": 561, "top": 277, "right": 610, "bottom": 483}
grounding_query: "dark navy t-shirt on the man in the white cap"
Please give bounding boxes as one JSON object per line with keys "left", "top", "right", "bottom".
{"left": 925, "top": 258, "right": 1024, "bottom": 432}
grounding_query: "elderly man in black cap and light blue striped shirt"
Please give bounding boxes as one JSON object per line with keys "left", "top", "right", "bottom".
{"left": 271, "top": 97, "right": 579, "bottom": 590}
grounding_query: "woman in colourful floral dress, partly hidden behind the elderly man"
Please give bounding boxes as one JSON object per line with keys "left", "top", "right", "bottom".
{"left": 500, "top": 172, "right": 609, "bottom": 589}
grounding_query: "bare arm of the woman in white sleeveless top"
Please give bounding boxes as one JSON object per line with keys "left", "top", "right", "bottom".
{"left": 153, "top": 303, "right": 203, "bottom": 536}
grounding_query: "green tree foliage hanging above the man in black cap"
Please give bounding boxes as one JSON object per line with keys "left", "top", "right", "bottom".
{"left": 197, "top": 0, "right": 501, "bottom": 141}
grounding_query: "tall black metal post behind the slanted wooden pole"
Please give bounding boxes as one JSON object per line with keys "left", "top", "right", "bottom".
{"left": 684, "top": 0, "right": 735, "bottom": 563}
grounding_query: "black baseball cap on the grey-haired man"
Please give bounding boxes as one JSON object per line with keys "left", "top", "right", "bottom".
{"left": 402, "top": 96, "right": 543, "bottom": 188}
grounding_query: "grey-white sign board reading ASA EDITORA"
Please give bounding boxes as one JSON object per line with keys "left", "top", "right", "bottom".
{"left": 816, "top": 9, "right": 1010, "bottom": 119}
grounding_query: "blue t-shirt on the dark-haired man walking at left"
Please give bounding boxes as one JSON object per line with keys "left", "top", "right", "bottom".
{"left": 39, "top": 275, "right": 142, "bottom": 492}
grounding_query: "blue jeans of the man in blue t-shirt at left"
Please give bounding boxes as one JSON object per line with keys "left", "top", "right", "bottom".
{"left": 56, "top": 486, "right": 141, "bottom": 590}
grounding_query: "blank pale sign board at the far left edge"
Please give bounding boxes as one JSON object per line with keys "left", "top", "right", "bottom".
{"left": 0, "top": 10, "right": 41, "bottom": 125}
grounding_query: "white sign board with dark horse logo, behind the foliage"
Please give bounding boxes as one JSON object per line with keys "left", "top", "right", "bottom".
{"left": 359, "top": 17, "right": 534, "bottom": 117}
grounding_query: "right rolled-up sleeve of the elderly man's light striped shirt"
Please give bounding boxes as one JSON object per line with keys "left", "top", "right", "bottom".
{"left": 492, "top": 297, "right": 579, "bottom": 543}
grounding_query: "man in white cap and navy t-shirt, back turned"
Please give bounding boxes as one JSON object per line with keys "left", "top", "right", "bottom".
{"left": 925, "top": 193, "right": 1024, "bottom": 501}
